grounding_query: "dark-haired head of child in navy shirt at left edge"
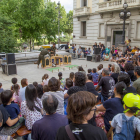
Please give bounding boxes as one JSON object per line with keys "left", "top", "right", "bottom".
{"left": 1, "top": 90, "right": 13, "bottom": 106}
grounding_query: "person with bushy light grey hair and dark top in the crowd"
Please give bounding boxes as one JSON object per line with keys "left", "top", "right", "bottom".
{"left": 111, "top": 63, "right": 120, "bottom": 84}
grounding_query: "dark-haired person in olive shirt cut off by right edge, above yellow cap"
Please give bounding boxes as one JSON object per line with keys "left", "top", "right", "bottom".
{"left": 133, "top": 66, "right": 140, "bottom": 95}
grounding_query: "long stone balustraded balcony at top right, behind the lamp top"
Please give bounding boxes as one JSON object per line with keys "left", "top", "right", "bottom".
{"left": 97, "top": 0, "right": 140, "bottom": 13}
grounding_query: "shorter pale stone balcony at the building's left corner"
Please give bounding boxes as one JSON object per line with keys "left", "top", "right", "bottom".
{"left": 73, "top": 7, "right": 91, "bottom": 17}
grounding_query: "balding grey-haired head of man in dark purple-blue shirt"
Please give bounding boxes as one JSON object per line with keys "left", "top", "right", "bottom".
{"left": 42, "top": 95, "right": 58, "bottom": 115}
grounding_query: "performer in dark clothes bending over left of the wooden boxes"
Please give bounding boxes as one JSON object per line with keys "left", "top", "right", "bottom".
{"left": 37, "top": 49, "right": 51, "bottom": 68}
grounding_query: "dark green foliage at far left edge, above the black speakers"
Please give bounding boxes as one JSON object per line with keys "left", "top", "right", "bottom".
{"left": 0, "top": 14, "right": 17, "bottom": 53}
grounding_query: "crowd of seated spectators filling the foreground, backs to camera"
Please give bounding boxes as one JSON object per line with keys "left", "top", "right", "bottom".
{"left": 0, "top": 44, "right": 140, "bottom": 140}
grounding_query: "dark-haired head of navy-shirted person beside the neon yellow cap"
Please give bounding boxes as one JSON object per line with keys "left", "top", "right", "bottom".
{"left": 114, "top": 82, "right": 127, "bottom": 99}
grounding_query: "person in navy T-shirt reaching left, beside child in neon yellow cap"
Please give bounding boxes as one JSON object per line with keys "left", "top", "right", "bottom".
{"left": 97, "top": 82, "right": 126, "bottom": 132}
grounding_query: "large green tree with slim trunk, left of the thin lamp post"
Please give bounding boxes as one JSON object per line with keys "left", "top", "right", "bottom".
{"left": 17, "top": 0, "right": 44, "bottom": 51}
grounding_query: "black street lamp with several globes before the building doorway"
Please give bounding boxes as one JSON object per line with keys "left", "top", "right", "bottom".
{"left": 119, "top": 2, "right": 131, "bottom": 45}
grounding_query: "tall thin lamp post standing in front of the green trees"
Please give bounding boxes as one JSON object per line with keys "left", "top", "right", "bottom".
{"left": 55, "top": 1, "right": 61, "bottom": 48}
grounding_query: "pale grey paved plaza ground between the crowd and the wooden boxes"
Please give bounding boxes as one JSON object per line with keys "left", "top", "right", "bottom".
{"left": 0, "top": 59, "right": 114, "bottom": 89}
